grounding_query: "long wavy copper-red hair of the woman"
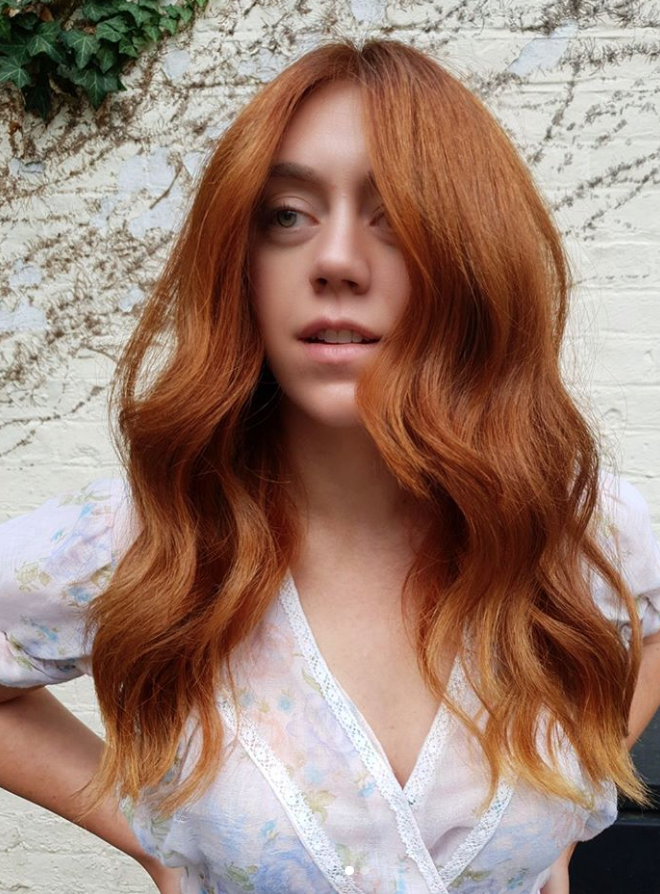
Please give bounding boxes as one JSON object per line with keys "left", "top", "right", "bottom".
{"left": 81, "top": 39, "right": 648, "bottom": 824}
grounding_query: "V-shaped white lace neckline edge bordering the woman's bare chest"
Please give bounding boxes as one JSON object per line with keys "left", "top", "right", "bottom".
{"left": 280, "top": 569, "right": 464, "bottom": 806}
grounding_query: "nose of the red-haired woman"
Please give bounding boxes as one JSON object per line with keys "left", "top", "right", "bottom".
{"left": 310, "top": 206, "right": 370, "bottom": 294}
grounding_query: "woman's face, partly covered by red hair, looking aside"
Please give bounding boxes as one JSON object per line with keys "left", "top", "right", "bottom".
{"left": 250, "top": 83, "right": 410, "bottom": 427}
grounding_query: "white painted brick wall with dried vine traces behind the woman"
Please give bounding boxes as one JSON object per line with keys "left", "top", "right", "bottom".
{"left": 0, "top": 0, "right": 660, "bottom": 894}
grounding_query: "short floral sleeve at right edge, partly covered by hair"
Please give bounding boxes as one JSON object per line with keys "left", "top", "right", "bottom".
{"left": 594, "top": 471, "right": 660, "bottom": 643}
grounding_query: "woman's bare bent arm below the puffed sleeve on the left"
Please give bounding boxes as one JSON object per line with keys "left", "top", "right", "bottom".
{"left": 0, "top": 686, "right": 180, "bottom": 894}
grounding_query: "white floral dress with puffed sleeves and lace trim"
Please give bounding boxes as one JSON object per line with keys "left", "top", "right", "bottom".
{"left": 0, "top": 472, "right": 660, "bottom": 894}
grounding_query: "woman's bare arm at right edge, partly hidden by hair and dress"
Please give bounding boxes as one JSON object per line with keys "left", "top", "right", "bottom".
{"left": 540, "top": 631, "right": 660, "bottom": 894}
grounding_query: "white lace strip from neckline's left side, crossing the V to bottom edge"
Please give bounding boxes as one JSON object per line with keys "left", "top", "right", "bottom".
{"left": 279, "top": 572, "right": 448, "bottom": 894}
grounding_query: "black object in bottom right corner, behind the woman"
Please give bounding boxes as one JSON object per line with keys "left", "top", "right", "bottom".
{"left": 569, "top": 811, "right": 660, "bottom": 894}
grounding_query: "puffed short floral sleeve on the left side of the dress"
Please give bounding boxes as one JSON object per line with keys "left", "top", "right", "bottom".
{"left": 0, "top": 478, "right": 130, "bottom": 687}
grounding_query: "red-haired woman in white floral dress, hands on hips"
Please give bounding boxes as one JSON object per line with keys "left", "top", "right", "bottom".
{"left": 0, "top": 40, "right": 660, "bottom": 894}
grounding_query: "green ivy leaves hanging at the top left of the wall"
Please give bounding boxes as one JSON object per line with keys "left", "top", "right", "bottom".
{"left": 0, "top": 0, "right": 207, "bottom": 120}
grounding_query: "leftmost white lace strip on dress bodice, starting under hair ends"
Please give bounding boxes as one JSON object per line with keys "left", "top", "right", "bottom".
{"left": 218, "top": 695, "right": 364, "bottom": 894}
